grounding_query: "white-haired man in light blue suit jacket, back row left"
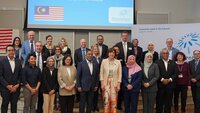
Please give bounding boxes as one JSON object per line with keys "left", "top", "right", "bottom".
{"left": 22, "top": 31, "right": 35, "bottom": 63}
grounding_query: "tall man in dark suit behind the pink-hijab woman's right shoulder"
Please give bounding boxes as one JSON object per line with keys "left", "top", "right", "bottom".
{"left": 115, "top": 31, "right": 133, "bottom": 67}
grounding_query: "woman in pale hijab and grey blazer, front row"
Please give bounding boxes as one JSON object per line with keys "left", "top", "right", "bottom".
{"left": 141, "top": 52, "right": 159, "bottom": 113}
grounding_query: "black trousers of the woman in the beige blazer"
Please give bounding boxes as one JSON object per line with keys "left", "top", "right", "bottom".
{"left": 59, "top": 95, "right": 75, "bottom": 113}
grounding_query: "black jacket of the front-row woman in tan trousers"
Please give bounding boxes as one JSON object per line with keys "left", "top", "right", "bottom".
{"left": 41, "top": 67, "right": 58, "bottom": 94}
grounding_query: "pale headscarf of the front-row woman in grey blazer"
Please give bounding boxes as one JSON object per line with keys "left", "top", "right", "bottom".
{"left": 144, "top": 52, "right": 153, "bottom": 78}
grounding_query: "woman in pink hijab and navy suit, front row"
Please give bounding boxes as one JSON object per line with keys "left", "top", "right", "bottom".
{"left": 122, "top": 55, "right": 142, "bottom": 113}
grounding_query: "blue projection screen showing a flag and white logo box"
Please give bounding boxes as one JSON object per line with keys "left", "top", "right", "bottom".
{"left": 27, "top": 0, "right": 135, "bottom": 30}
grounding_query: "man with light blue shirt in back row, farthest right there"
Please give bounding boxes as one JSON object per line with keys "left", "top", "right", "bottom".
{"left": 166, "top": 38, "right": 179, "bottom": 60}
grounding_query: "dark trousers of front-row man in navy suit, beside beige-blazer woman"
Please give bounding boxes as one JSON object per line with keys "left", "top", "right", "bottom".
{"left": 79, "top": 91, "right": 94, "bottom": 113}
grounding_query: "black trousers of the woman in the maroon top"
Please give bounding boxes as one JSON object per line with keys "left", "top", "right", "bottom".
{"left": 174, "top": 85, "right": 187, "bottom": 112}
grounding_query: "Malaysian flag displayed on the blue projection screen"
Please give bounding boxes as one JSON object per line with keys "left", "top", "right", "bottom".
{"left": 34, "top": 6, "right": 64, "bottom": 21}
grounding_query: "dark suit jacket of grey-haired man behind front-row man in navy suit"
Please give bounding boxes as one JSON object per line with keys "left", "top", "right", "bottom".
{"left": 74, "top": 48, "right": 89, "bottom": 67}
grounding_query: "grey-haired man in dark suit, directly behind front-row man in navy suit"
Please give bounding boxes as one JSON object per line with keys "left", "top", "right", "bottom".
{"left": 74, "top": 38, "right": 89, "bottom": 67}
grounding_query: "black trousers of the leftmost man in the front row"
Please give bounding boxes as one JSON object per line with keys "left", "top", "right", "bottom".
{"left": 1, "top": 89, "right": 20, "bottom": 113}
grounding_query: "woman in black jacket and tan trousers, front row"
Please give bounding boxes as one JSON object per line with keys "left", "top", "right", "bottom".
{"left": 42, "top": 57, "right": 58, "bottom": 113}
